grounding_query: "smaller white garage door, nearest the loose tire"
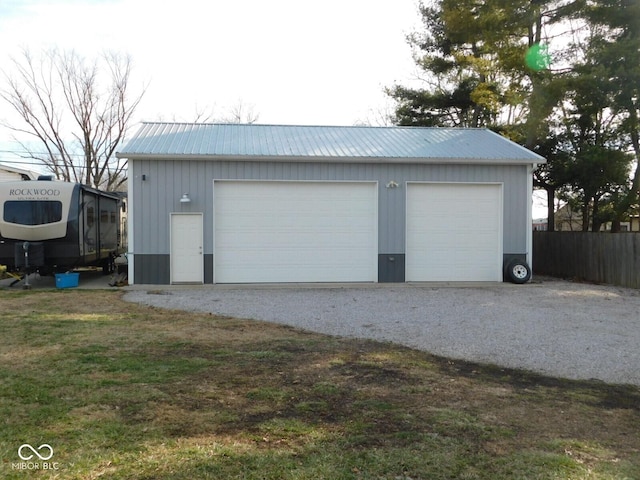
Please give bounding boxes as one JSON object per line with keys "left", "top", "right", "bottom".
{"left": 405, "top": 183, "right": 502, "bottom": 281}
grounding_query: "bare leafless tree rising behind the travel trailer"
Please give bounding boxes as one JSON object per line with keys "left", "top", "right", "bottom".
{"left": 0, "top": 50, "right": 145, "bottom": 190}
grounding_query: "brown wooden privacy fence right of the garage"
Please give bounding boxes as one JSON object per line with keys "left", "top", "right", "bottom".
{"left": 533, "top": 232, "right": 640, "bottom": 288}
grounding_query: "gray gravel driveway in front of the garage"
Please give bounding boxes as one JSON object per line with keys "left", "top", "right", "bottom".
{"left": 125, "top": 278, "right": 640, "bottom": 386}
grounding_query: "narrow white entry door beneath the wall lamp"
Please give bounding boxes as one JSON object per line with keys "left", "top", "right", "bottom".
{"left": 171, "top": 213, "right": 204, "bottom": 283}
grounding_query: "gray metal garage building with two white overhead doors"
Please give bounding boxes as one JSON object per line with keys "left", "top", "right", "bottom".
{"left": 118, "top": 123, "right": 545, "bottom": 284}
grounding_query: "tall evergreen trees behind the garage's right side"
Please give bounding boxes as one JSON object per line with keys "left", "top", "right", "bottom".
{"left": 388, "top": 0, "right": 640, "bottom": 229}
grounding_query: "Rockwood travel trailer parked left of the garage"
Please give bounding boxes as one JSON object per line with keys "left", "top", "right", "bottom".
{"left": 0, "top": 179, "right": 126, "bottom": 274}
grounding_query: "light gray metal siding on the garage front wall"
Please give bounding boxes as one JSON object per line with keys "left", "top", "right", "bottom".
{"left": 129, "top": 160, "right": 531, "bottom": 268}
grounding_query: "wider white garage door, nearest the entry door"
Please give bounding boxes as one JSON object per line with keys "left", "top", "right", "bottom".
{"left": 214, "top": 181, "right": 378, "bottom": 283}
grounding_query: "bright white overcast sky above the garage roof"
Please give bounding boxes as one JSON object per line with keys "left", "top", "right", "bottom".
{"left": 0, "top": 0, "right": 552, "bottom": 216}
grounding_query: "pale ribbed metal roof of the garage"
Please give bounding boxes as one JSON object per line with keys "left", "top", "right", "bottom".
{"left": 117, "top": 122, "right": 545, "bottom": 163}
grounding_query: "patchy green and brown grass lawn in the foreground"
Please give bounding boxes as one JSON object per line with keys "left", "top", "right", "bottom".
{"left": 0, "top": 290, "right": 640, "bottom": 480}
